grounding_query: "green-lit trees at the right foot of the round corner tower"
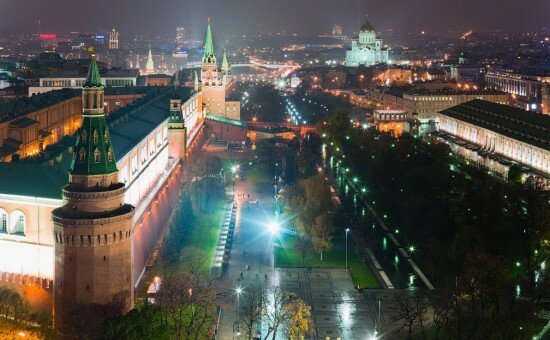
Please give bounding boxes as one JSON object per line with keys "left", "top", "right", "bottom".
{"left": 102, "top": 251, "right": 219, "bottom": 339}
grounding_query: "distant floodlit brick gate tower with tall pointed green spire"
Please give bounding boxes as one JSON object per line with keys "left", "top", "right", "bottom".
{"left": 196, "top": 19, "right": 241, "bottom": 120}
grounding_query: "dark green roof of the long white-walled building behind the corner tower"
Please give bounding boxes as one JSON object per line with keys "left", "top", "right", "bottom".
{"left": 0, "top": 87, "right": 194, "bottom": 200}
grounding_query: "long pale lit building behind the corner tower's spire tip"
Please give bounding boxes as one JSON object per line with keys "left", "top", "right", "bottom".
{"left": 29, "top": 68, "right": 139, "bottom": 97}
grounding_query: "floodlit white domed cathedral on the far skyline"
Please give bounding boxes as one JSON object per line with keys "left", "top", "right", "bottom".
{"left": 346, "top": 21, "right": 389, "bottom": 67}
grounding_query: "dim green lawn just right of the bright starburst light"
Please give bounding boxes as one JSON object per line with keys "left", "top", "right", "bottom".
{"left": 275, "top": 232, "right": 380, "bottom": 288}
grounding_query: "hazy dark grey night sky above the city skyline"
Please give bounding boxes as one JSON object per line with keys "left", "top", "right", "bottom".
{"left": 0, "top": 0, "right": 550, "bottom": 37}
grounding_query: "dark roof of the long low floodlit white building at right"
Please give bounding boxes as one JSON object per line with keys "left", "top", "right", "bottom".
{"left": 440, "top": 99, "right": 550, "bottom": 151}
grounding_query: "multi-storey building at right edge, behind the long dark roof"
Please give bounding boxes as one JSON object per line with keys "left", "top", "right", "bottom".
{"left": 485, "top": 70, "right": 550, "bottom": 112}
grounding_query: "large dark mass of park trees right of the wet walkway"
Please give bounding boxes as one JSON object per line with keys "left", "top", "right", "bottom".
{"left": 323, "top": 113, "right": 550, "bottom": 338}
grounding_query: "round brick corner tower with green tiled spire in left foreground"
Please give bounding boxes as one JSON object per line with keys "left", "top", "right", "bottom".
{"left": 52, "top": 54, "right": 134, "bottom": 336}
